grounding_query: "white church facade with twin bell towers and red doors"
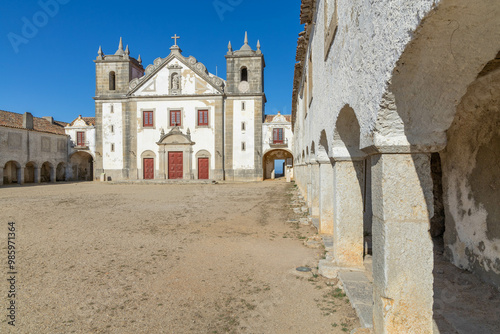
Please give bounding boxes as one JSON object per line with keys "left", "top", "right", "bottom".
{"left": 94, "top": 35, "right": 266, "bottom": 181}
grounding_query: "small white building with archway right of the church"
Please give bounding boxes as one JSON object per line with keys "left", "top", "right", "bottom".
{"left": 262, "top": 112, "right": 293, "bottom": 179}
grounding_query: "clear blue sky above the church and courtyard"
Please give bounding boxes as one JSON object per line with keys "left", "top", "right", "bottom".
{"left": 0, "top": 0, "right": 303, "bottom": 122}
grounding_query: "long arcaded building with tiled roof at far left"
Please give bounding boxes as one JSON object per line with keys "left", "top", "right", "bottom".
{"left": 0, "top": 110, "right": 70, "bottom": 185}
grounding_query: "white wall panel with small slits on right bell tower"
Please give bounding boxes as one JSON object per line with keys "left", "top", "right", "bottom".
{"left": 231, "top": 100, "right": 255, "bottom": 169}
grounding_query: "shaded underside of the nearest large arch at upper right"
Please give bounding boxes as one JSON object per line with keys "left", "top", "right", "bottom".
{"left": 376, "top": 0, "right": 500, "bottom": 152}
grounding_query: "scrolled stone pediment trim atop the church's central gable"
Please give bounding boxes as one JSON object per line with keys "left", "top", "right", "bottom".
{"left": 128, "top": 51, "right": 225, "bottom": 95}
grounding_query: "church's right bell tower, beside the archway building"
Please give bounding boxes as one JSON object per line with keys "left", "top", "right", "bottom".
{"left": 224, "top": 32, "right": 266, "bottom": 181}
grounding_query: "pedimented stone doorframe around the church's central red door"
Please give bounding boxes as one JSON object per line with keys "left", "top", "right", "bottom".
{"left": 156, "top": 126, "right": 195, "bottom": 180}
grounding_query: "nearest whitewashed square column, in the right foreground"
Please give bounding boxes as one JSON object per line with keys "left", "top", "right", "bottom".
{"left": 372, "top": 153, "right": 434, "bottom": 334}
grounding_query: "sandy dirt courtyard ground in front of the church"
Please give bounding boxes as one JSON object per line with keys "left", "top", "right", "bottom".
{"left": 0, "top": 182, "right": 359, "bottom": 334}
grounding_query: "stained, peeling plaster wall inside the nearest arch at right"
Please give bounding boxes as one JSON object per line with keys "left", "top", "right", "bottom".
{"left": 441, "top": 70, "right": 500, "bottom": 287}
